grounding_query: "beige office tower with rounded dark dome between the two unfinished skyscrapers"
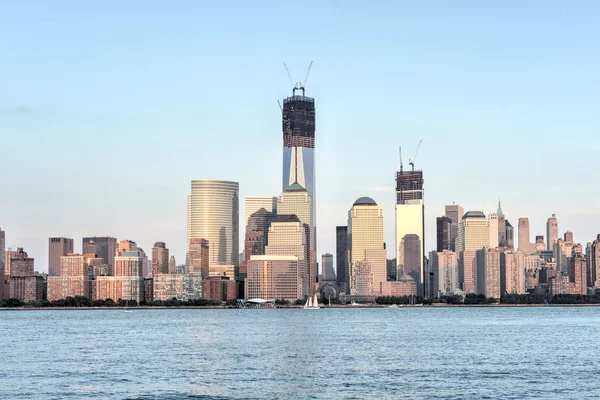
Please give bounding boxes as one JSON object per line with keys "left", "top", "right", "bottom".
{"left": 348, "top": 197, "right": 387, "bottom": 296}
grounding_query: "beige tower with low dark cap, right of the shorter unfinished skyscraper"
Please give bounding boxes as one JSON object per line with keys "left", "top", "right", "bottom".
{"left": 457, "top": 211, "right": 490, "bottom": 293}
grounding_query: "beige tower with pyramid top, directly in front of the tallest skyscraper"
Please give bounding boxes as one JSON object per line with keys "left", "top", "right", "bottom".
{"left": 277, "top": 183, "right": 318, "bottom": 294}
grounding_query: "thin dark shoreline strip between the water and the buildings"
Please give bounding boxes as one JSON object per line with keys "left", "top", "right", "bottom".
{"left": 0, "top": 303, "right": 600, "bottom": 312}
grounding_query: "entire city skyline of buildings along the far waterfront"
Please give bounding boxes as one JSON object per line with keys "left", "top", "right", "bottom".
{"left": 0, "top": 85, "right": 600, "bottom": 303}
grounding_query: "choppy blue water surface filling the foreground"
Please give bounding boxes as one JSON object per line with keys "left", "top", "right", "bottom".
{"left": 0, "top": 307, "right": 600, "bottom": 400}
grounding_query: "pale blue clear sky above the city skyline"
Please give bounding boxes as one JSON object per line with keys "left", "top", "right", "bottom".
{"left": 0, "top": 0, "right": 600, "bottom": 271}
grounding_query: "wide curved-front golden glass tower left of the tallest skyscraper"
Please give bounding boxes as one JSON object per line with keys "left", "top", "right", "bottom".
{"left": 189, "top": 180, "right": 240, "bottom": 266}
